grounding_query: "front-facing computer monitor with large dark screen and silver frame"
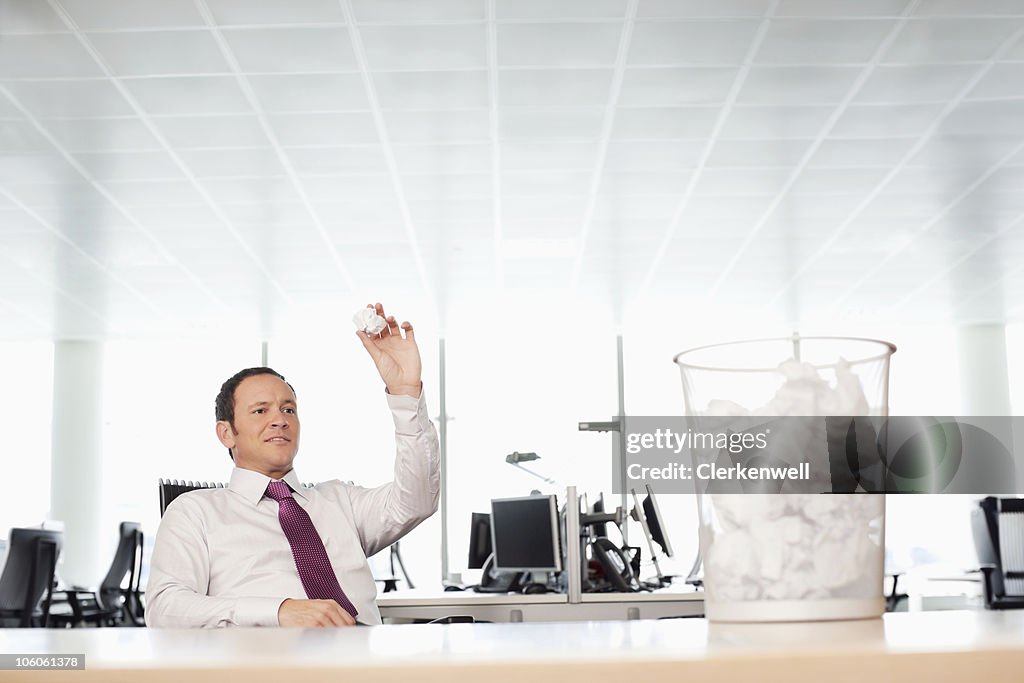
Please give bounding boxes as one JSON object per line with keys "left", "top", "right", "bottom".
{"left": 490, "top": 496, "right": 562, "bottom": 571}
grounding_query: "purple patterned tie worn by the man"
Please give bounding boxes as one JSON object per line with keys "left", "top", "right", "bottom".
{"left": 266, "top": 481, "right": 358, "bottom": 618}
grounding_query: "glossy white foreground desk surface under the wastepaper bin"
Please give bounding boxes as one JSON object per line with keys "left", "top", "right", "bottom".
{"left": 0, "top": 611, "right": 1024, "bottom": 683}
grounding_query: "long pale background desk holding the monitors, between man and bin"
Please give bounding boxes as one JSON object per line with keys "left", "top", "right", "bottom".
{"left": 377, "top": 587, "right": 703, "bottom": 622}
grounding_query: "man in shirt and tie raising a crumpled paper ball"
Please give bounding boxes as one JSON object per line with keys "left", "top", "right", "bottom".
{"left": 146, "top": 303, "right": 440, "bottom": 628}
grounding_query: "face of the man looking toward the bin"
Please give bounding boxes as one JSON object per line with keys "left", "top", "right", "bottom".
{"left": 217, "top": 375, "right": 299, "bottom": 479}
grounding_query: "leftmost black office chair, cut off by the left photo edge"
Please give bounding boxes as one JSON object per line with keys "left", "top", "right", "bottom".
{"left": 0, "top": 528, "right": 63, "bottom": 628}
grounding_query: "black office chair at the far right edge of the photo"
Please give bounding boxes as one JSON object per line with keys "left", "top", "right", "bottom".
{"left": 971, "top": 496, "right": 1024, "bottom": 609}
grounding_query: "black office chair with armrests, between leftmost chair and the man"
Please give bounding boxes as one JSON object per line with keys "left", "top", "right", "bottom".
{"left": 53, "top": 522, "right": 145, "bottom": 627}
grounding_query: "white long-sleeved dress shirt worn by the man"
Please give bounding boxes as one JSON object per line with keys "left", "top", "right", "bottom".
{"left": 145, "top": 393, "right": 440, "bottom": 628}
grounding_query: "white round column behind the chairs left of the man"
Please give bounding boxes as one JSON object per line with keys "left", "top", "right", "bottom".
{"left": 49, "top": 341, "right": 103, "bottom": 586}
